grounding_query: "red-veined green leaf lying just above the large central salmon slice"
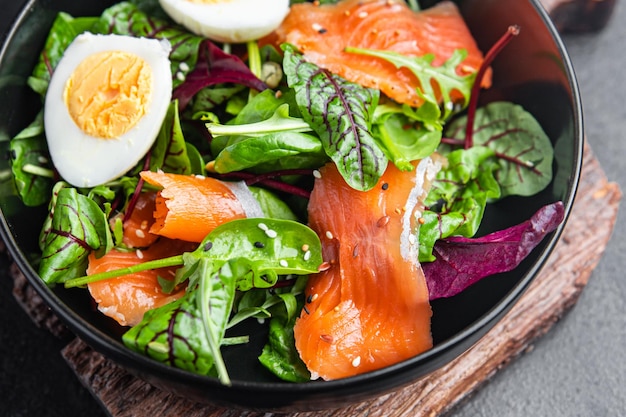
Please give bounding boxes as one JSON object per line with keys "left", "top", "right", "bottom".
{"left": 283, "top": 45, "right": 388, "bottom": 191}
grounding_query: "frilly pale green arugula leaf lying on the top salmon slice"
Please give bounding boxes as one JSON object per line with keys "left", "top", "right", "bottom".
{"left": 346, "top": 47, "right": 476, "bottom": 124}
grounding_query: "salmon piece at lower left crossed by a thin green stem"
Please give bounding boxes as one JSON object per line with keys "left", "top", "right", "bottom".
{"left": 87, "top": 238, "right": 197, "bottom": 326}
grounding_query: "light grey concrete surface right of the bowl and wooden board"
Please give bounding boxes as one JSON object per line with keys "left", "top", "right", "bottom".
{"left": 452, "top": 2, "right": 626, "bottom": 417}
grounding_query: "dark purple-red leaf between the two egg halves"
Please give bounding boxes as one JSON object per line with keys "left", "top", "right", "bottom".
{"left": 173, "top": 40, "right": 267, "bottom": 110}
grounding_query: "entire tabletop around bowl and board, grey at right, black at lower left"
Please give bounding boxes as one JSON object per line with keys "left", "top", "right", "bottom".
{"left": 0, "top": 0, "right": 626, "bottom": 417}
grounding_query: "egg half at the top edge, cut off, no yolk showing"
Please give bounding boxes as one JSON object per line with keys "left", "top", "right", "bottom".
{"left": 159, "top": 0, "right": 289, "bottom": 43}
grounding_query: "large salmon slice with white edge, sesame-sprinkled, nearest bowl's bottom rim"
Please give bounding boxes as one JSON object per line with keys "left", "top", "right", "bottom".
{"left": 294, "top": 158, "right": 440, "bottom": 380}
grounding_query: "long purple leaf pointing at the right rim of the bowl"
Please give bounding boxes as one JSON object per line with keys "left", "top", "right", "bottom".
{"left": 422, "top": 201, "right": 565, "bottom": 300}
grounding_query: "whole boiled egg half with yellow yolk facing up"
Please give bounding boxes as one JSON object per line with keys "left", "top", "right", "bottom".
{"left": 44, "top": 33, "right": 172, "bottom": 187}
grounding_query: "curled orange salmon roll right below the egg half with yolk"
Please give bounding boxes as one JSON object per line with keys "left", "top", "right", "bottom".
{"left": 140, "top": 171, "right": 246, "bottom": 242}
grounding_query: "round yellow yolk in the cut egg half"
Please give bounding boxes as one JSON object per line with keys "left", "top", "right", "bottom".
{"left": 63, "top": 51, "right": 152, "bottom": 139}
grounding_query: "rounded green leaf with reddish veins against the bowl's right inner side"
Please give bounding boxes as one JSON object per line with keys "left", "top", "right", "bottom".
{"left": 446, "top": 102, "right": 554, "bottom": 198}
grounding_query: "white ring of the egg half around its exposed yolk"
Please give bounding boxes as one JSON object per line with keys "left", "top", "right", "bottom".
{"left": 44, "top": 33, "right": 172, "bottom": 187}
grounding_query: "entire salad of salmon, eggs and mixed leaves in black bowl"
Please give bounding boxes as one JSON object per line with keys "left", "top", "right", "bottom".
{"left": 11, "top": 0, "right": 564, "bottom": 384}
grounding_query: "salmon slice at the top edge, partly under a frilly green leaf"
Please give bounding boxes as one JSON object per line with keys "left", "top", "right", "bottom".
{"left": 266, "top": 0, "right": 491, "bottom": 107}
